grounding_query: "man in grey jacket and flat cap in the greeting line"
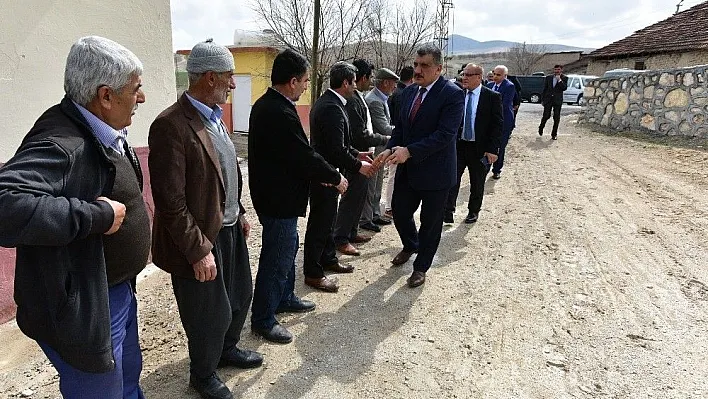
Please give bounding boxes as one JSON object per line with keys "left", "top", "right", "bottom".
{"left": 359, "top": 68, "right": 400, "bottom": 227}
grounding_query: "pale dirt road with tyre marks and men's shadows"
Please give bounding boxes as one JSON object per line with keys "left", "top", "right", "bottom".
{"left": 0, "top": 104, "right": 708, "bottom": 399}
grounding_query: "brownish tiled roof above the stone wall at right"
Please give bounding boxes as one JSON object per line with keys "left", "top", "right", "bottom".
{"left": 589, "top": 1, "right": 708, "bottom": 58}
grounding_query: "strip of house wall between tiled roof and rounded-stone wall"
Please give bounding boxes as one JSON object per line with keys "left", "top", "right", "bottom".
{"left": 587, "top": 50, "right": 708, "bottom": 76}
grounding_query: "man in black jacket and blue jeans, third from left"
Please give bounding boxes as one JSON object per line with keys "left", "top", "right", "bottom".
{"left": 248, "top": 50, "right": 347, "bottom": 343}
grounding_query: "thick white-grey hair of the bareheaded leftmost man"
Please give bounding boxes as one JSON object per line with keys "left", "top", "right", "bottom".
{"left": 64, "top": 36, "right": 143, "bottom": 107}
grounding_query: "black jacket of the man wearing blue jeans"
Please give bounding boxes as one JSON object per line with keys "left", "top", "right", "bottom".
{"left": 248, "top": 88, "right": 340, "bottom": 219}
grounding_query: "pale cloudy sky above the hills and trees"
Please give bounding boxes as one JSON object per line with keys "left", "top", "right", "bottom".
{"left": 171, "top": 0, "right": 704, "bottom": 50}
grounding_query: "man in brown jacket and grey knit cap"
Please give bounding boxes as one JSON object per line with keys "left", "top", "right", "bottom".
{"left": 148, "top": 40, "right": 263, "bottom": 398}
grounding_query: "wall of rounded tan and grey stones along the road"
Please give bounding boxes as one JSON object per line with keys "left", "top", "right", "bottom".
{"left": 580, "top": 65, "right": 708, "bottom": 138}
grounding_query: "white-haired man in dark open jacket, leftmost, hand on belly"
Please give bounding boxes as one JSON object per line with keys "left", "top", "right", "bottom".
{"left": 0, "top": 36, "right": 150, "bottom": 398}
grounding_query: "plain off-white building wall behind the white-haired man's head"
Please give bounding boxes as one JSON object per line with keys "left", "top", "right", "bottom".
{"left": 0, "top": 0, "right": 176, "bottom": 163}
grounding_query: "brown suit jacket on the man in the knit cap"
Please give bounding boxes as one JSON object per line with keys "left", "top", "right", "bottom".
{"left": 148, "top": 94, "right": 245, "bottom": 278}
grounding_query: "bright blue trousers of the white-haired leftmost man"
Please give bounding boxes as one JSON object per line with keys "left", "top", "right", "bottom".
{"left": 39, "top": 282, "right": 145, "bottom": 399}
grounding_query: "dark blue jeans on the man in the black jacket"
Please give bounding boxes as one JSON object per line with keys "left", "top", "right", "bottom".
{"left": 251, "top": 215, "right": 299, "bottom": 329}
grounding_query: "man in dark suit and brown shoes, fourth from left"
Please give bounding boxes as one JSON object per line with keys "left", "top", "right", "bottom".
{"left": 303, "top": 62, "right": 374, "bottom": 292}
